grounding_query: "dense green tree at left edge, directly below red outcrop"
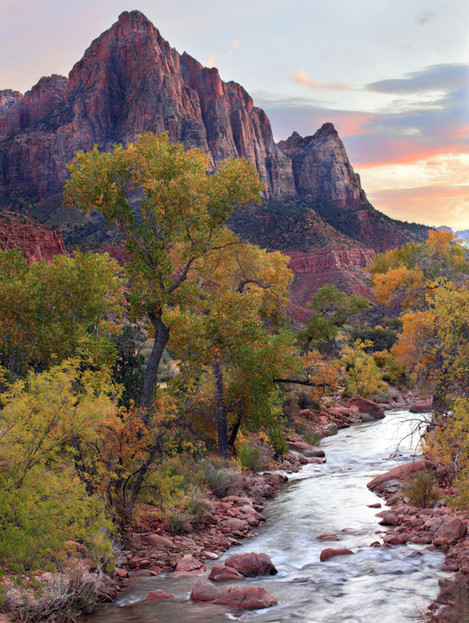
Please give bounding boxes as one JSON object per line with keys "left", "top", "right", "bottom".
{"left": 0, "top": 250, "right": 123, "bottom": 376}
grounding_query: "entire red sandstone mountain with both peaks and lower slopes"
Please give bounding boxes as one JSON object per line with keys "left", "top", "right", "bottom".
{"left": 0, "top": 11, "right": 426, "bottom": 310}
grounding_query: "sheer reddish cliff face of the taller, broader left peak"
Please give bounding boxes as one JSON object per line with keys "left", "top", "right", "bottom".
{"left": 0, "top": 11, "right": 295, "bottom": 205}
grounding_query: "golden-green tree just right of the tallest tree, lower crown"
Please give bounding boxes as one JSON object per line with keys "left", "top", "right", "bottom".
{"left": 164, "top": 229, "right": 293, "bottom": 458}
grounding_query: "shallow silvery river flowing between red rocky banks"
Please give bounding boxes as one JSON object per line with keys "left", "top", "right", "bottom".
{"left": 85, "top": 411, "right": 445, "bottom": 623}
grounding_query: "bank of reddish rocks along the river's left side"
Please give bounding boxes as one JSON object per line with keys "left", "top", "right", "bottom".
{"left": 0, "top": 398, "right": 408, "bottom": 620}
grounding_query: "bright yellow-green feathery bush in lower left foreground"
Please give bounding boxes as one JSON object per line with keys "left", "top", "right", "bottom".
{"left": 0, "top": 361, "right": 113, "bottom": 571}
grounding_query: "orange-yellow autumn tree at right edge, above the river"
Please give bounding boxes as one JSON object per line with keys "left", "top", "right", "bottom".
{"left": 372, "top": 232, "right": 469, "bottom": 415}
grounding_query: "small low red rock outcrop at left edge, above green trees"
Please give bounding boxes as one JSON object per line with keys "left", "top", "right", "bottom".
{"left": 0, "top": 210, "right": 65, "bottom": 262}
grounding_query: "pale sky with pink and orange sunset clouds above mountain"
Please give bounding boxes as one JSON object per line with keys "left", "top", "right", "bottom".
{"left": 0, "top": 0, "right": 469, "bottom": 230}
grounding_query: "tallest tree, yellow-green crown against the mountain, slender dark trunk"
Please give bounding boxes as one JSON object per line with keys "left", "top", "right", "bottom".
{"left": 64, "top": 134, "right": 262, "bottom": 420}
